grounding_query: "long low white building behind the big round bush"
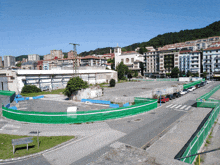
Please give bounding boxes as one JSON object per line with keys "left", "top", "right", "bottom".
{"left": 0, "top": 70, "right": 118, "bottom": 93}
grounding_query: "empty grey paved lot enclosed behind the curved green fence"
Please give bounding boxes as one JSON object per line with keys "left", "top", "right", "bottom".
{"left": 11, "top": 81, "right": 188, "bottom": 112}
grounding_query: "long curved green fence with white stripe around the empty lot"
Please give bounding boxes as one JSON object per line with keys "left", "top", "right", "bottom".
{"left": 2, "top": 98, "right": 157, "bottom": 124}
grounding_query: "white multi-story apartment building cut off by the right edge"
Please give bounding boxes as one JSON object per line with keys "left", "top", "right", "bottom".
{"left": 203, "top": 47, "right": 220, "bottom": 75}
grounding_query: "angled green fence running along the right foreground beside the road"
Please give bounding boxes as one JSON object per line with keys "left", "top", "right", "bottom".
{"left": 181, "top": 85, "right": 220, "bottom": 164}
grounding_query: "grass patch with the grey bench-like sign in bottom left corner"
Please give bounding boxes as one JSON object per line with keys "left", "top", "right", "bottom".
{"left": 0, "top": 134, "right": 75, "bottom": 159}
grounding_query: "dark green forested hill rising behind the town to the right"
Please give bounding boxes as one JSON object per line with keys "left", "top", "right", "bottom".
{"left": 79, "top": 21, "right": 220, "bottom": 56}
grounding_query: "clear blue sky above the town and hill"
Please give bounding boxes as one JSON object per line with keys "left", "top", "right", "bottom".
{"left": 0, "top": 0, "right": 220, "bottom": 56}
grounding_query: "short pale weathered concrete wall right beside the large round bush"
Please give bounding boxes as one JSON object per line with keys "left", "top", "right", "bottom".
{"left": 70, "top": 87, "right": 102, "bottom": 101}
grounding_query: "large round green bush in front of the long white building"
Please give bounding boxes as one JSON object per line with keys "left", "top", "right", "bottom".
{"left": 63, "top": 77, "right": 88, "bottom": 97}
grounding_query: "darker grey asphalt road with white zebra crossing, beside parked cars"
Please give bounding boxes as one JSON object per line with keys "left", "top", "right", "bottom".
{"left": 0, "top": 83, "right": 219, "bottom": 165}
